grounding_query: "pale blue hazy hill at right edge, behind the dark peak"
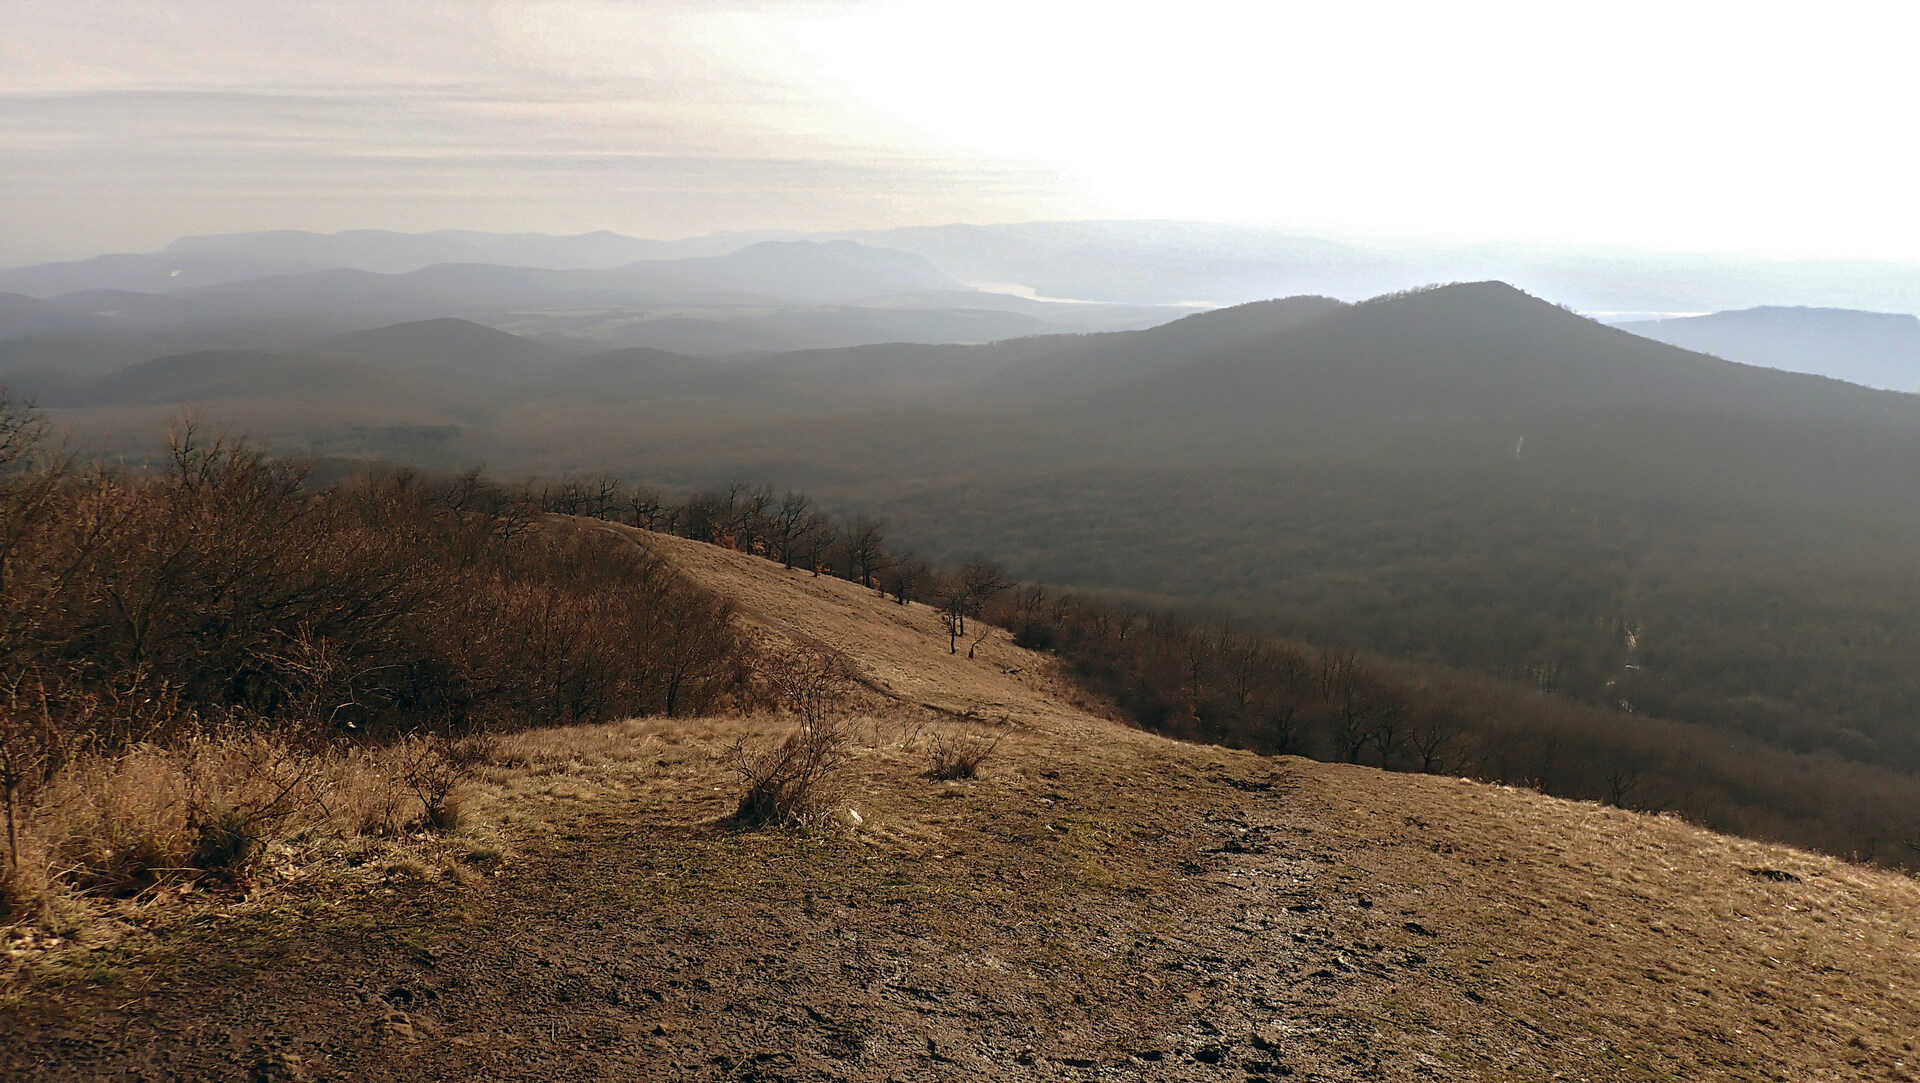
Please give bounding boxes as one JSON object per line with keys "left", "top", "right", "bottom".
{"left": 1615, "top": 307, "right": 1920, "bottom": 392}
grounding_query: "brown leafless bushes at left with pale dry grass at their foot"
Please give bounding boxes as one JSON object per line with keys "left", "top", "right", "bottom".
{"left": 0, "top": 401, "right": 747, "bottom": 920}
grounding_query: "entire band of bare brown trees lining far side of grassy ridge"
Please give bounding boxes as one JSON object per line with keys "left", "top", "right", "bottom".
{"left": 518, "top": 466, "right": 1920, "bottom": 866}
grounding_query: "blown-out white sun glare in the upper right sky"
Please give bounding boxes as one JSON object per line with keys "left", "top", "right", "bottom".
{"left": 741, "top": 2, "right": 1920, "bottom": 253}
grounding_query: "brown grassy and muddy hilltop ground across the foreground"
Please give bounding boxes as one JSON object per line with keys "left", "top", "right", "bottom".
{"left": 0, "top": 542, "right": 1920, "bottom": 1081}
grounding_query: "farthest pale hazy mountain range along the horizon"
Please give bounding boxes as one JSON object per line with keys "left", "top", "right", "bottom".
{"left": 18, "top": 221, "right": 1920, "bottom": 314}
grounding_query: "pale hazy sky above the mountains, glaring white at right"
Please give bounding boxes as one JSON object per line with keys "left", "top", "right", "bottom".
{"left": 0, "top": 0, "right": 1920, "bottom": 263}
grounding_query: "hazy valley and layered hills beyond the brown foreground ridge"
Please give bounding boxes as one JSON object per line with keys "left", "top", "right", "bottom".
{"left": 11, "top": 227, "right": 1920, "bottom": 791}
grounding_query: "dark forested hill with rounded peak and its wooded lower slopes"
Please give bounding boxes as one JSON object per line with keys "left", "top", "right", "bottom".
{"left": 30, "top": 282, "right": 1920, "bottom": 783}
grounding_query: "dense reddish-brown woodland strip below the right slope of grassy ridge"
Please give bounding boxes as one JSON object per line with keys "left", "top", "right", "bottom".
{"left": 1000, "top": 583, "right": 1920, "bottom": 866}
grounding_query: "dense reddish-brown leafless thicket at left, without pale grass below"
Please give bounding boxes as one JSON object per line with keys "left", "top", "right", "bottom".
{"left": 0, "top": 426, "right": 747, "bottom": 749}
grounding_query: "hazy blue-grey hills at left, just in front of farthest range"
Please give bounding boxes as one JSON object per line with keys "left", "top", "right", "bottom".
{"left": 0, "top": 240, "right": 1013, "bottom": 353}
